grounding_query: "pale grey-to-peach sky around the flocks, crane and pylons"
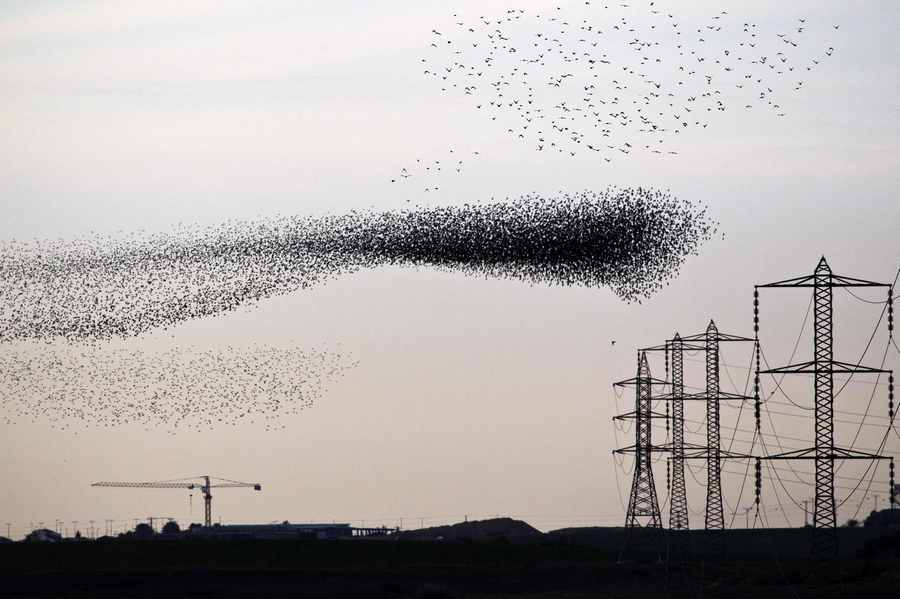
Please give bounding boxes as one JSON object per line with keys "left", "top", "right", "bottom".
{"left": 0, "top": 0, "right": 900, "bottom": 536}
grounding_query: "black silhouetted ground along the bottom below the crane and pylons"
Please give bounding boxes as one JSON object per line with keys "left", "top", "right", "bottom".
{"left": 0, "top": 529, "right": 900, "bottom": 599}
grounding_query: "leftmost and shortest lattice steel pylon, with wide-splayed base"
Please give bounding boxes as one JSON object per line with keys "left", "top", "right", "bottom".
{"left": 614, "top": 352, "right": 665, "bottom": 528}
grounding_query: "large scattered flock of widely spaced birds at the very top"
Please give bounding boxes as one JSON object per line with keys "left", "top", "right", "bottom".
{"left": 412, "top": 3, "right": 831, "bottom": 166}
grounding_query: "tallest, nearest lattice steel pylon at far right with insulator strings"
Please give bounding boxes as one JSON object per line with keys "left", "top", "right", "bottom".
{"left": 753, "top": 256, "right": 894, "bottom": 558}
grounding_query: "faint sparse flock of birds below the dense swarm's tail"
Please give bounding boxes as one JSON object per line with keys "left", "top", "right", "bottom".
{"left": 0, "top": 343, "right": 355, "bottom": 433}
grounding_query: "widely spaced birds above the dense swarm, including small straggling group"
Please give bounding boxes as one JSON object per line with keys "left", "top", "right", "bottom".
{"left": 392, "top": 0, "right": 840, "bottom": 182}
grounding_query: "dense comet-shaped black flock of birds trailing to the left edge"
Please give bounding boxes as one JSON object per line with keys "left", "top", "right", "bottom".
{"left": 0, "top": 188, "right": 716, "bottom": 342}
